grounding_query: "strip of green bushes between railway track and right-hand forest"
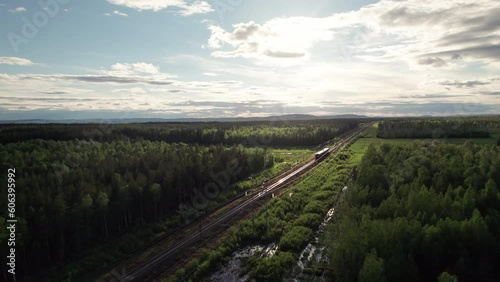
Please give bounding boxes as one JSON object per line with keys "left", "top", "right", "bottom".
{"left": 166, "top": 145, "right": 352, "bottom": 282}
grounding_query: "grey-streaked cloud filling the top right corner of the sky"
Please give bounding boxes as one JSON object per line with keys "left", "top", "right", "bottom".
{"left": 364, "top": 0, "right": 500, "bottom": 68}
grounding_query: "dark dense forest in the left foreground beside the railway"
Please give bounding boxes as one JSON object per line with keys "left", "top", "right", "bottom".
{"left": 0, "top": 139, "right": 273, "bottom": 277}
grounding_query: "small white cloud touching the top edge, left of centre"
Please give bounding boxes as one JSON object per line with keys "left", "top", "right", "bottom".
{"left": 107, "top": 0, "right": 214, "bottom": 16}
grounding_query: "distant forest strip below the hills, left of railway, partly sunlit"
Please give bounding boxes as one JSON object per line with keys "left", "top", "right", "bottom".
{"left": 0, "top": 119, "right": 359, "bottom": 146}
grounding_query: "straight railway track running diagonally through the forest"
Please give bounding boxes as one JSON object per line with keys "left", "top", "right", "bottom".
{"left": 115, "top": 128, "right": 364, "bottom": 282}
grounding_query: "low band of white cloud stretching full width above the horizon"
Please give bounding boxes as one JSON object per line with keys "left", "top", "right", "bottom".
{"left": 0, "top": 63, "right": 500, "bottom": 117}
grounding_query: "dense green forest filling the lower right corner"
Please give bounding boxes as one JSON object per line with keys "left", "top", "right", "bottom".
{"left": 327, "top": 141, "right": 500, "bottom": 282}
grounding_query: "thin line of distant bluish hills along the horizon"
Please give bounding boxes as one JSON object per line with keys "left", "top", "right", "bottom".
{"left": 0, "top": 114, "right": 368, "bottom": 124}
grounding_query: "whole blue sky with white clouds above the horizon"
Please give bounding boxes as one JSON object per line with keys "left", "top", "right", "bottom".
{"left": 0, "top": 0, "right": 500, "bottom": 120}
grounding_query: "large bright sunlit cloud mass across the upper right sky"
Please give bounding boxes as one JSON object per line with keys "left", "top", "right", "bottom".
{"left": 205, "top": 0, "right": 500, "bottom": 67}
